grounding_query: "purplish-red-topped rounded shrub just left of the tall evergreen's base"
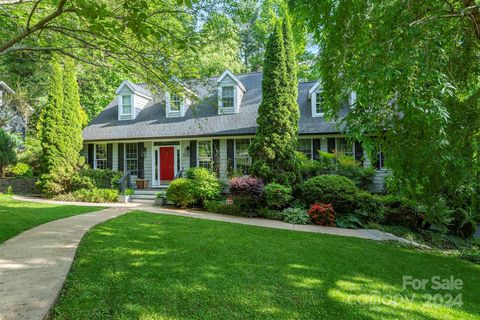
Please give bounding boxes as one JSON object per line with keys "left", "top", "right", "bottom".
{"left": 230, "top": 176, "right": 264, "bottom": 216}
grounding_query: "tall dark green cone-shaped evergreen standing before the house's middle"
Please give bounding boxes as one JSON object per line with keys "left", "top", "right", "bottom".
{"left": 249, "top": 21, "right": 298, "bottom": 184}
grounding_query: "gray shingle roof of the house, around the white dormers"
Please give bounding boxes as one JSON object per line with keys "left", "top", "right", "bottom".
{"left": 83, "top": 72, "right": 346, "bottom": 141}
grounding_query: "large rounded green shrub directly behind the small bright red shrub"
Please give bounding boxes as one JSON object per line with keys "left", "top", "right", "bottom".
{"left": 302, "top": 175, "right": 358, "bottom": 214}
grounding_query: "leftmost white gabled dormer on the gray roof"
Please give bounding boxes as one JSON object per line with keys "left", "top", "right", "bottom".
{"left": 115, "top": 80, "right": 153, "bottom": 120}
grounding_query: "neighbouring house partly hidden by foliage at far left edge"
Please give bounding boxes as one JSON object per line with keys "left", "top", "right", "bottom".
{"left": 0, "top": 81, "right": 33, "bottom": 137}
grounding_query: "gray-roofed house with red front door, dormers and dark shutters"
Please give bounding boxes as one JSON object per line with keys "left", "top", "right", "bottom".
{"left": 83, "top": 70, "right": 383, "bottom": 189}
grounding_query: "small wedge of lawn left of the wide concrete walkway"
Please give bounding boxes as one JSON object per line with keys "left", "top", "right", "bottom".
{"left": 0, "top": 195, "right": 101, "bottom": 243}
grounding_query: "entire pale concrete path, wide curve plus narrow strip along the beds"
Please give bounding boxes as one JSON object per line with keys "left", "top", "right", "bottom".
{"left": 0, "top": 196, "right": 425, "bottom": 320}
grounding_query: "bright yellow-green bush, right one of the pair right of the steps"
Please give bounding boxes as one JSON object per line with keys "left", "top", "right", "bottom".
{"left": 187, "top": 168, "right": 222, "bottom": 204}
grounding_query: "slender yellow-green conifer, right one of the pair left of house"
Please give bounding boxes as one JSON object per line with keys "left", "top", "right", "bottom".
{"left": 63, "top": 58, "right": 83, "bottom": 167}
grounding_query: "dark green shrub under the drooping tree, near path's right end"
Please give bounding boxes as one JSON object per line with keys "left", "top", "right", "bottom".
{"left": 382, "top": 195, "right": 422, "bottom": 230}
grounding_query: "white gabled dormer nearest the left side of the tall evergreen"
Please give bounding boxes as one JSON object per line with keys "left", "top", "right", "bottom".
{"left": 217, "top": 70, "right": 247, "bottom": 114}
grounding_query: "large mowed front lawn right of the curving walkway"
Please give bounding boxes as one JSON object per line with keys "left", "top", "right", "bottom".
{"left": 53, "top": 212, "right": 480, "bottom": 320}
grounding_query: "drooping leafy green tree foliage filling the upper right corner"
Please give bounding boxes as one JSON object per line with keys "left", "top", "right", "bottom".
{"left": 292, "top": 0, "right": 480, "bottom": 200}
